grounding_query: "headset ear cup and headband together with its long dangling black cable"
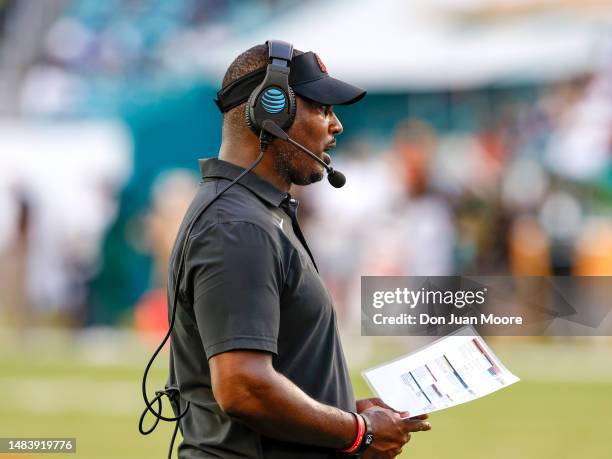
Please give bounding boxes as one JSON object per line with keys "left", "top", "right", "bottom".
{"left": 138, "top": 40, "right": 296, "bottom": 459}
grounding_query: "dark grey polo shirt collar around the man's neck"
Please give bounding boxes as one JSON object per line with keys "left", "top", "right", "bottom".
{"left": 199, "top": 158, "right": 289, "bottom": 207}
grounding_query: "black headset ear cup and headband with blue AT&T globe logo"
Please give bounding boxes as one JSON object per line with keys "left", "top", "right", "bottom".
{"left": 245, "top": 40, "right": 296, "bottom": 135}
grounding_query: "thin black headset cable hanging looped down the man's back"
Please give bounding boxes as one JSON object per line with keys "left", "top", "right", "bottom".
{"left": 138, "top": 140, "right": 270, "bottom": 459}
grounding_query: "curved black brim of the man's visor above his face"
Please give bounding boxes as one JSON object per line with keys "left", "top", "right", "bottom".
{"left": 291, "top": 76, "right": 366, "bottom": 105}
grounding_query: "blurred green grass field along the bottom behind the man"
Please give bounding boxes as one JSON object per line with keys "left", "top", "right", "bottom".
{"left": 0, "top": 332, "right": 612, "bottom": 459}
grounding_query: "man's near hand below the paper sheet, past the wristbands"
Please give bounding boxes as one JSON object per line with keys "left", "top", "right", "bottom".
{"left": 357, "top": 406, "right": 431, "bottom": 459}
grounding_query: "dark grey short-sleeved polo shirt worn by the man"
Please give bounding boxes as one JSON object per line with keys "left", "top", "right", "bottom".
{"left": 168, "top": 159, "right": 355, "bottom": 459}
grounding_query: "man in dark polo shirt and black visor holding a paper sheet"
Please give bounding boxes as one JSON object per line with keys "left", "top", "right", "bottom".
{"left": 169, "top": 45, "right": 430, "bottom": 459}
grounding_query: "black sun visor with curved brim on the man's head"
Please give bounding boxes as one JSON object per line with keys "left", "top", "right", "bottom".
{"left": 215, "top": 51, "right": 366, "bottom": 113}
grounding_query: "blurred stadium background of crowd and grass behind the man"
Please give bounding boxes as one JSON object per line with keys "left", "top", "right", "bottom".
{"left": 0, "top": 0, "right": 612, "bottom": 459}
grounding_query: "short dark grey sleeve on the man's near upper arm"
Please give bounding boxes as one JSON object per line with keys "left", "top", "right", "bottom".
{"left": 187, "top": 222, "right": 284, "bottom": 359}
